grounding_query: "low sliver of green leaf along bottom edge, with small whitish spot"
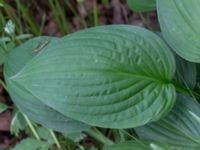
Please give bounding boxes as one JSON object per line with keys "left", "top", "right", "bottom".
{"left": 104, "top": 140, "right": 175, "bottom": 150}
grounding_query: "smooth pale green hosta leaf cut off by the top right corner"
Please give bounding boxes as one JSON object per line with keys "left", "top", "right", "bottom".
{"left": 157, "top": 0, "right": 200, "bottom": 62}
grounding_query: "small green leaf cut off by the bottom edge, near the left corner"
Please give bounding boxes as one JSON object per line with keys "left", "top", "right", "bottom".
{"left": 11, "top": 138, "right": 51, "bottom": 150}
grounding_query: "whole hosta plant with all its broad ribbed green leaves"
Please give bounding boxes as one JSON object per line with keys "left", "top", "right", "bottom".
{"left": 0, "top": 0, "right": 200, "bottom": 150}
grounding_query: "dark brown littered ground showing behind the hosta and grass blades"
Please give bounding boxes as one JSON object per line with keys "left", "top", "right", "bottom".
{"left": 0, "top": 0, "right": 159, "bottom": 150}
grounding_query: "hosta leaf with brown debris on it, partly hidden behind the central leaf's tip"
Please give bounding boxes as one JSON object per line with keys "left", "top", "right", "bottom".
{"left": 4, "top": 37, "right": 87, "bottom": 132}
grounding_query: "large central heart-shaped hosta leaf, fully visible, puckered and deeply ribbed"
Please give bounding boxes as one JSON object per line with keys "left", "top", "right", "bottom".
{"left": 7, "top": 25, "right": 175, "bottom": 128}
